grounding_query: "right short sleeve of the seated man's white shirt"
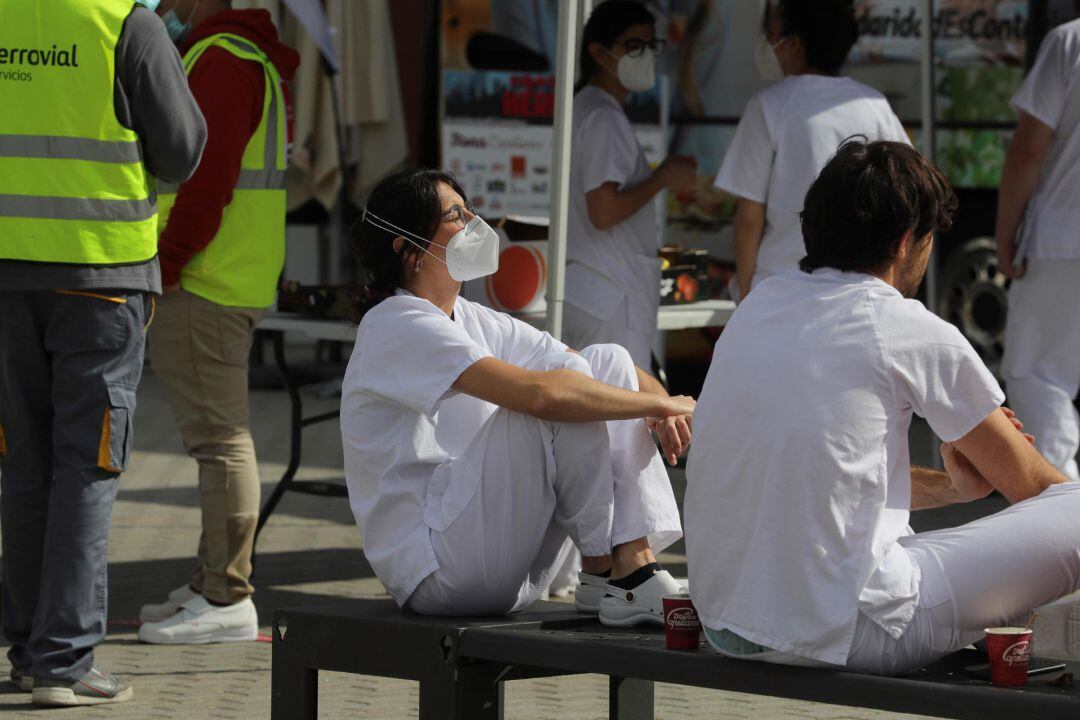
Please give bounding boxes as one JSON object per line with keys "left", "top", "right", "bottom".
{"left": 887, "top": 308, "right": 1004, "bottom": 443}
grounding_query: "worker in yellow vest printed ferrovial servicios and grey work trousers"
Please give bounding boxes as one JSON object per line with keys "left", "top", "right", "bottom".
{"left": 0, "top": 0, "right": 206, "bottom": 705}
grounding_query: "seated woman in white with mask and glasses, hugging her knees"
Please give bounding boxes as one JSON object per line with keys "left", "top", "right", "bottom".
{"left": 341, "top": 171, "right": 694, "bottom": 625}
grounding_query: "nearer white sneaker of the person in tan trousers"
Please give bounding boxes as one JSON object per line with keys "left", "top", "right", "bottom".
{"left": 138, "top": 595, "right": 259, "bottom": 644}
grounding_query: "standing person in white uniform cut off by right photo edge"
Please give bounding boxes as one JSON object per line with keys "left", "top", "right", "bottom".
{"left": 996, "top": 15, "right": 1080, "bottom": 481}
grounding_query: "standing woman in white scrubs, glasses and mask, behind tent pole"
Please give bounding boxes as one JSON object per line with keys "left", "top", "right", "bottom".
{"left": 564, "top": 0, "right": 697, "bottom": 371}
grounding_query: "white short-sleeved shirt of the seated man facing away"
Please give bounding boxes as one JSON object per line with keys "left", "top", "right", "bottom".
{"left": 684, "top": 269, "right": 1004, "bottom": 665}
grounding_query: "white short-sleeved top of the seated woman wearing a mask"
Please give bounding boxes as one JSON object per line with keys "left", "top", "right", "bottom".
{"left": 341, "top": 291, "right": 566, "bottom": 606}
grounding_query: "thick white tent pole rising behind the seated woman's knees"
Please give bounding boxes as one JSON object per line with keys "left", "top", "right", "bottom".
{"left": 548, "top": 0, "right": 578, "bottom": 339}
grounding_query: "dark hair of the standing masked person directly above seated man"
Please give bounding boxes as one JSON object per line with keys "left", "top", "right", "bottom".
{"left": 775, "top": 0, "right": 859, "bottom": 76}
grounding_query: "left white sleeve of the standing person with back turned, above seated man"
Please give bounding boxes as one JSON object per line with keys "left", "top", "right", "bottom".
{"left": 716, "top": 94, "right": 777, "bottom": 204}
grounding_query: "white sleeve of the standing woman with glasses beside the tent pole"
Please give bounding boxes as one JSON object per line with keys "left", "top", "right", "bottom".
{"left": 577, "top": 107, "right": 642, "bottom": 192}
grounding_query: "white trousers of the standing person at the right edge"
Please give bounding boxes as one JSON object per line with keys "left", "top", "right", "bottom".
{"left": 1001, "top": 260, "right": 1080, "bottom": 481}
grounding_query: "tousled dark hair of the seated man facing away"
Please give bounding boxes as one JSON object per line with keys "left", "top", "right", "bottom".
{"left": 799, "top": 136, "right": 957, "bottom": 272}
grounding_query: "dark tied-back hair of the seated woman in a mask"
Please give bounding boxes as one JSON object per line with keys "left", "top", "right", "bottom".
{"left": 351, "top": 168, "right": 469, "bottom": 323}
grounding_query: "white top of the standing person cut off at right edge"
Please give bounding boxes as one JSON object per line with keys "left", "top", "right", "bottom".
{"left": 1012, "top": 19, "right": 1080, "bottom": 260}
